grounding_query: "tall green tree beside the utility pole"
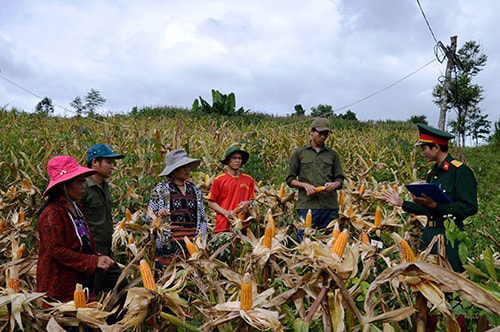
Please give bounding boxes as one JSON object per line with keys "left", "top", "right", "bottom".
{"left": 432, "top": 41, "right": 489, "bottom": 146}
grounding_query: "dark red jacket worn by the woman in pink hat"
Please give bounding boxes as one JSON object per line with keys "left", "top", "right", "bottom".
{"left": 36, "top": 197, "right": 99, "bottom": 302}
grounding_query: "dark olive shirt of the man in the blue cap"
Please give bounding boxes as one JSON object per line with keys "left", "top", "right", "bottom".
{"left": 80, "top": 176, "right": 114, "bottom": 258}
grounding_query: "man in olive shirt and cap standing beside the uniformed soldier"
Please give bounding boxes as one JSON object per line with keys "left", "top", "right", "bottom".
{"left": 286, "top": 118, "right": 344, "bottom": 241}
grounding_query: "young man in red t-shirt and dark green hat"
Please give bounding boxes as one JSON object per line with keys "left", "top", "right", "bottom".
{"left": 208, "top": 146, "right": 255, "bottom": 233}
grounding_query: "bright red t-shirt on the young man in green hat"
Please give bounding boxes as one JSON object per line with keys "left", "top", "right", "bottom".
{"left": 208, "top": 172, "right": 255, "bottom": 233}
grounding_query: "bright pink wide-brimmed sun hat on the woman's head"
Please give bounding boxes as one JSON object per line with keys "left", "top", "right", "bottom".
{"left": 43, "top": 156, "right": 97, "bottom": 196}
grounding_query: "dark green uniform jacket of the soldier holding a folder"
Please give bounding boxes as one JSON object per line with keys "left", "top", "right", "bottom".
{"left": 403, "top": 154, "right": 478, "bottom": 223}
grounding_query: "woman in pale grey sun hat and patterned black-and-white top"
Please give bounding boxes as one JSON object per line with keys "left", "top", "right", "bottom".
{"left": 149, "top": 149, "right": 207, "bottom": 268}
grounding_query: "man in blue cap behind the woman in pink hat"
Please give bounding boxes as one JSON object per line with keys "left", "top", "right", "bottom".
{"left": 81, "top": 144, "right": 125, "bottom": 292}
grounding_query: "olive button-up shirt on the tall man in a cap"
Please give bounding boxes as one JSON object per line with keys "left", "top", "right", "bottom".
{"left": 286, "top": 142, "right": 344, "bottom": 209}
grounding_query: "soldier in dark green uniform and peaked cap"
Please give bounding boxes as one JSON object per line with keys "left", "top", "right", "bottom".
{"left": 384, "top": 124, "right": 478, "bottom": 272}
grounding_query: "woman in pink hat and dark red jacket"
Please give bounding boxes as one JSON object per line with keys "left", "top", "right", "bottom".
{"left": 36, "top": 156, "right": 114, "bottom": 302}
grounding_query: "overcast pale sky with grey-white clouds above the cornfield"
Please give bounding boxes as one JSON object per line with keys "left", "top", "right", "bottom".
{"left": 0, "top": 0, "right": 500, "bottom": 126}
